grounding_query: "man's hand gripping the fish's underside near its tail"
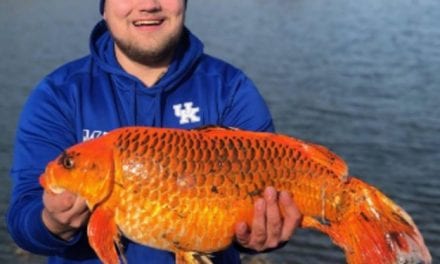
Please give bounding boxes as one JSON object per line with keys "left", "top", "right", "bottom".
{"left": 235, "top": 187, "right": 302, "bottom": 252}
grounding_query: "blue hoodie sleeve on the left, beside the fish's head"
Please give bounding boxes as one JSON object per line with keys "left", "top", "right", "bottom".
{"left": 6, "top": 79, "right": 80, "bottom": 255}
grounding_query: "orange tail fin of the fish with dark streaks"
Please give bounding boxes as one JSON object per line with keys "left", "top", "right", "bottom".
{"left": 303, "top": 178, "right": 432, "bottom": 264}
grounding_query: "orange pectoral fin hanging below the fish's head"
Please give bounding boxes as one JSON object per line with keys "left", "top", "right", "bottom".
{"left": 87, "top": 207, "right": 125, "bottom": 264}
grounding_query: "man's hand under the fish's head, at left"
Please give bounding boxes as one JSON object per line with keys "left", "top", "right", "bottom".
{"left": 42, "top": 191, "right": 90, "bottom": 240}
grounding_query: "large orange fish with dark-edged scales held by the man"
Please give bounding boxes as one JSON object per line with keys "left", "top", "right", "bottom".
{"left": 40, "top": 127, "right": 431, "bottom": 264}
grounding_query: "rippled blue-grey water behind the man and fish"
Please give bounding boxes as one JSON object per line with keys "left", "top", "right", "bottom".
{"left": 0, "top": 0, "right": 440, "bottom": 263}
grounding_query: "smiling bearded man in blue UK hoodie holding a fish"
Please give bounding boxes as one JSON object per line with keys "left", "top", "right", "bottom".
{"left": 7, "top": 0, "right": 300, "bottom": 263}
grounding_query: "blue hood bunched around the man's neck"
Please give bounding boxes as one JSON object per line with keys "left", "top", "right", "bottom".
{"left": 90, "top": 20, "right": 203, "bottom": 94}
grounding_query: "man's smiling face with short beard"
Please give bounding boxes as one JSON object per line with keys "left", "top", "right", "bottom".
{"left": 104, "top": 0, "right": 185, "bottom": 65}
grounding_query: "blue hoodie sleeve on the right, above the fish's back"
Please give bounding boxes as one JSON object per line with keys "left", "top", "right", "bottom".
{"left": 221, "top": 72, "right": 275, "bottom": 132}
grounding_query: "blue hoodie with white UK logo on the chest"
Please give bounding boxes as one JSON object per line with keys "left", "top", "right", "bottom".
{"left": 7, "top": 21, "right": 273, "bottom": 263}
